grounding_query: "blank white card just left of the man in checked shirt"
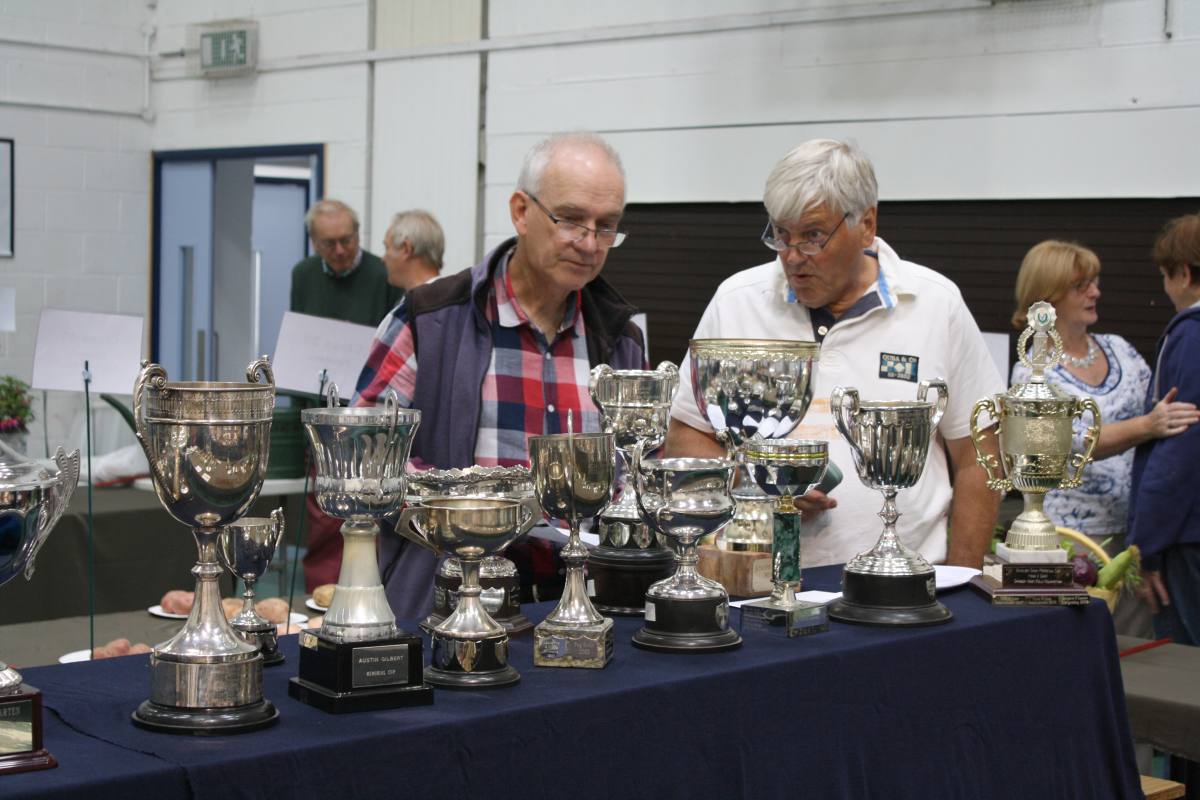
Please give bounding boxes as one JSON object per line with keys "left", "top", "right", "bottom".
{"left": 271, "top": 311, "right": 374, "bottom": 399}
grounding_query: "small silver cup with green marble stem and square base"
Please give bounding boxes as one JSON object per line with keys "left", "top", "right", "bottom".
{"left": 739, "top": 439, "right": 829, "bottom": 637}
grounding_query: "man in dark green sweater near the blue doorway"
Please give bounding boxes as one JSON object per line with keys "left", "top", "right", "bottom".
{"left": 292, "top": 199, "right": 404, "bottom": 327}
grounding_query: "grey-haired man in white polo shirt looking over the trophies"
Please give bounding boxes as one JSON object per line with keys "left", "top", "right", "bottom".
{"left": 666, "top": 139, "right": 1004, "bottom": 567}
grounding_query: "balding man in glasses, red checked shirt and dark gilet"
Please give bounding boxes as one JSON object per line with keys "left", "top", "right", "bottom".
{"left": 354, "top": 133, "right": 646, "bottom": 619}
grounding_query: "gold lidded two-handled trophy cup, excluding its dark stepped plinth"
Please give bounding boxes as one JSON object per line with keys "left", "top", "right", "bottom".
{"left": 971, "top": 301, "right": 1102, "bottom": 561}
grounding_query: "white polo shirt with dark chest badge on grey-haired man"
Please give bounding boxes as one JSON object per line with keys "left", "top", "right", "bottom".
{"left": 671, "top": 239, "right": 1004, "bottom": 566}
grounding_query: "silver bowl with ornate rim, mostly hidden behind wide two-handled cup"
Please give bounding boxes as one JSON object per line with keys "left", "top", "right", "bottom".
{"left": 408, "top": 465, "right": 533, "bottom": 636}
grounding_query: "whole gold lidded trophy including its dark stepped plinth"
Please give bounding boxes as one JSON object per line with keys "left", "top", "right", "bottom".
{"left": 971, "top": 301, "right": 1100, "bottom": 604}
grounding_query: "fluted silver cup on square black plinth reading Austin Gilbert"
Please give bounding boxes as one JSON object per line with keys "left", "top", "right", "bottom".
{"left": 288, "top": 385, "right": 433, "bottom": 714}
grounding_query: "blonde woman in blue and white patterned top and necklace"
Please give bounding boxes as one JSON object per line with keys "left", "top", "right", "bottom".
{"left": 1012, "top": 240, "right": 1200, "bottom": 634}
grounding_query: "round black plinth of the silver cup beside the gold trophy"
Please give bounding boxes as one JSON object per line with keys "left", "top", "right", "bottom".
{"left": 829, "top": 571, "right": 953, "bottom": 626}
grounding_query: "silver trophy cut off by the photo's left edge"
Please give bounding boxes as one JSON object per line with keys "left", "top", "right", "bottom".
{"left": 0, "top": 445, "right": 79, "bottom": 775}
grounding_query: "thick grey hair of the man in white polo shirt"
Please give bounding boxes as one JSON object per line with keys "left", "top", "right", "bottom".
{"left": 762, "top": 139, "right": 880, "bottom": 224}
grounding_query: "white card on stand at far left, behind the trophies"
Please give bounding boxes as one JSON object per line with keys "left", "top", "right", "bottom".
{"left": 30, "top": 308, "right": 143, "bottom": 395}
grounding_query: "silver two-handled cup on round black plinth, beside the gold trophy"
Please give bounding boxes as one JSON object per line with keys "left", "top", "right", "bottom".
{"left": 829, "top": 378, "right": 950, "bottom": 625}
